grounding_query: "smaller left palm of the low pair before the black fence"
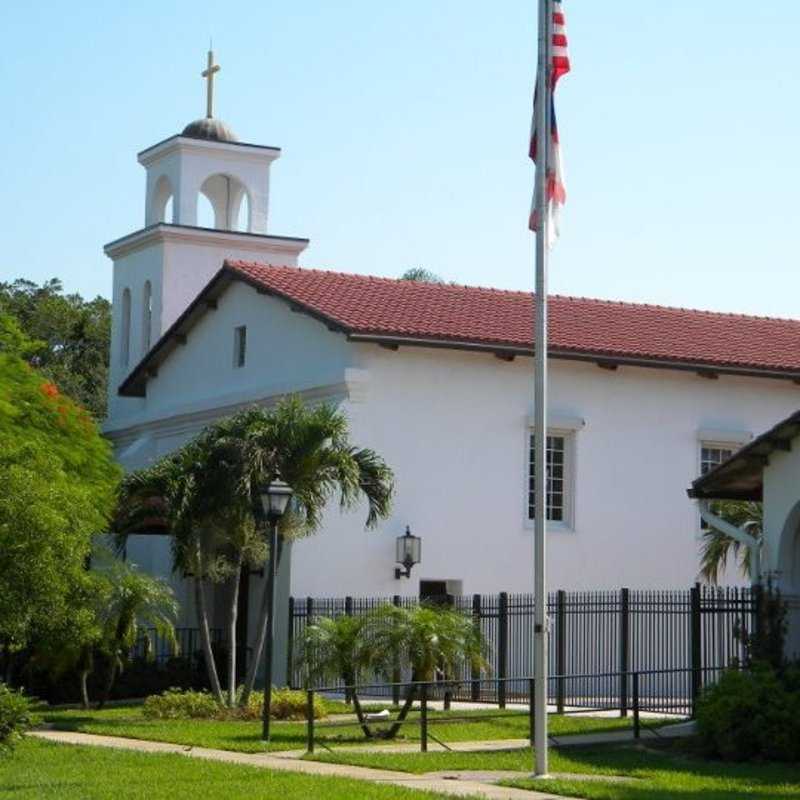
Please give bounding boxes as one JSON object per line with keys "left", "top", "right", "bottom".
{"left": 297, "top": 616, "right": 374, "bottom": 737}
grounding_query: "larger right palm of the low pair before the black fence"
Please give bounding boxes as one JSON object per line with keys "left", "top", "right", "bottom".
{"left": 370, "top": 605, "right": 489, "bottom": 739}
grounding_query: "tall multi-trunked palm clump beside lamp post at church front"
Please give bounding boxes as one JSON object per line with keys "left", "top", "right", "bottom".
{"left": 117, "top": 398, "right": 393, "bottom": 705}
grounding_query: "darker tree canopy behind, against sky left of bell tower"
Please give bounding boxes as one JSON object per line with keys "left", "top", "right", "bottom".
{"left": 0, "top": 278, "right": 111, "bottom": 419}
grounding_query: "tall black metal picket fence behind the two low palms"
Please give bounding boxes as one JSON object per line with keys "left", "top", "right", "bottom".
{"left": 288, "top": 586, "right": 758, "bottom": 713}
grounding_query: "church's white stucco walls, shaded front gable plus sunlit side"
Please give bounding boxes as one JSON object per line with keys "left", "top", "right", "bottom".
{"left": 113, "top": 283, "right": 800, "bottom": 596}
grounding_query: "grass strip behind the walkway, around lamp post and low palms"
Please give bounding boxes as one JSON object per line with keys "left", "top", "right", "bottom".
{"left": 40, "top": 706, "right": 644, "bottom": 753}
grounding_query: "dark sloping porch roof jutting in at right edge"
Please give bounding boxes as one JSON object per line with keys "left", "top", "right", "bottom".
{"left": 688, "top": 411, "right": 800, "bottom": 500}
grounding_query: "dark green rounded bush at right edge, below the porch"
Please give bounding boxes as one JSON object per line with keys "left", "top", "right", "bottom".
{"left": 697, "top": 664, "right": 800, "bottom": 761}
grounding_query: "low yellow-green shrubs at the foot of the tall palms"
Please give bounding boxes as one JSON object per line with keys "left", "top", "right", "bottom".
{"left": 142, "top": 688, "right": 327, "bottom": 720}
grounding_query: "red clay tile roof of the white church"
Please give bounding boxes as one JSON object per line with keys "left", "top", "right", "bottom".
{"left": 226, "top": 261, "right": 800, "bottom": 373}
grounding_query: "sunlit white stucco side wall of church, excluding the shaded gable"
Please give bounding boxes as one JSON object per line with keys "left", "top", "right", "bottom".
{"left": 292, "top": 345, "right": 800, "bottom": 596}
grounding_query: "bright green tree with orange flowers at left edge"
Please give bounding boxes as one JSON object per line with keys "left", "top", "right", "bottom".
{"left": 0, "top": 324, "right": 120, "bottom": 668}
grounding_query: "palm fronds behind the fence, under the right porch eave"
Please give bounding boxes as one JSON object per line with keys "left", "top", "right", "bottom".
{"left": 700, "top": 500, "right": 764, "bottom": 583}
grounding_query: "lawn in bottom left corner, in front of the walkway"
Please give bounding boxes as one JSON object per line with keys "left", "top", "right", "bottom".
{"left": 0, "top": 739, "right": 454, "bottom": 800}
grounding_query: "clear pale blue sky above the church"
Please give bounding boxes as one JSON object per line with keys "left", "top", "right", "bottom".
{"left": 0, "top": 0, "right": 800, "bottom": 317}
